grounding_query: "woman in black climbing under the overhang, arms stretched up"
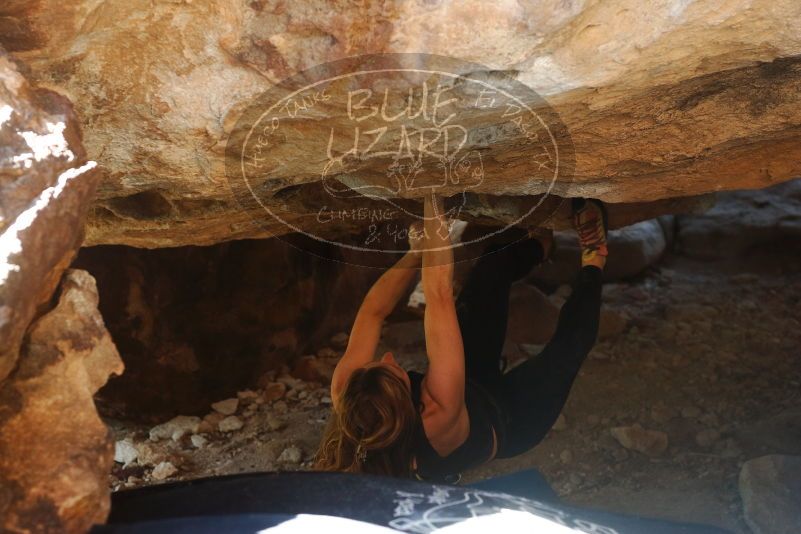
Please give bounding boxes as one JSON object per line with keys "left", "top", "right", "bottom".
{"left": 316, "top": 195, "right": 607, "bottom": 482}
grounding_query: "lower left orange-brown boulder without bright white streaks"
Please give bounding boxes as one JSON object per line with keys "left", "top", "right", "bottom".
{"left": 0, "top": 270, "right": 123, "bottom": 532}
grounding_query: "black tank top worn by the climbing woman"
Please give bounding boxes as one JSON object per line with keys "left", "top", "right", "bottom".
{"left": 408, "top": 371, "right": 503, "bottom": 482}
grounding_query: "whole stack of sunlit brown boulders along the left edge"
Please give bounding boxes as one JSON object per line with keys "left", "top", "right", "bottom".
{"left": 0, "top": 48, "right": 122, "bottom": 532}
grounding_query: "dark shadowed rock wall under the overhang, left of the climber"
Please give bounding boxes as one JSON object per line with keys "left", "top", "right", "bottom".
{"left": 74, "top": 239, "right": 382, "bottom": 422}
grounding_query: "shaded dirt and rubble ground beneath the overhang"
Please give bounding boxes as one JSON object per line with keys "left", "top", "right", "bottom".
{"left": 108, "top": 252, "right": 801, "bottom": 533}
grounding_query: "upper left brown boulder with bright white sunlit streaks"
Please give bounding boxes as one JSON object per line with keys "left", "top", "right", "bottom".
{"left": 0, "top": 49, "right": 100, "bottom": 381}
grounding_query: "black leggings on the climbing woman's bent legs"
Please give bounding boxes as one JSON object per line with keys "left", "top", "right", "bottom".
{"left": 456, "top": 239, "right": 602, "bottom": 458}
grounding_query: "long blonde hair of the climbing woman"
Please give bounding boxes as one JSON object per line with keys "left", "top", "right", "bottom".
{"left": 315, "top": 366, "right": 419, "bottom": 477}
